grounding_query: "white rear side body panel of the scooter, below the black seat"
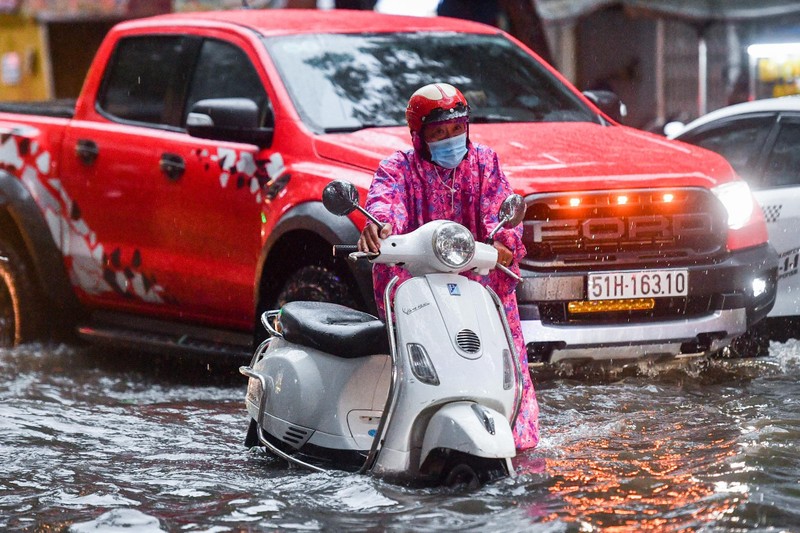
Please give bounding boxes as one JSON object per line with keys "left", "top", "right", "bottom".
{"left": 246, "top": 338, "right": 391, "bottom": 450}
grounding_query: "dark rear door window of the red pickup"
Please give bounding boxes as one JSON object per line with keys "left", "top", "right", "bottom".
{"left": 98, "top": 36, "right": 197, "bottom": 127}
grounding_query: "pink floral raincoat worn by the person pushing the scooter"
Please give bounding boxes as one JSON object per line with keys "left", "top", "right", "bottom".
{"left": 366, "top": 143, "right": 539, "bottom": 450}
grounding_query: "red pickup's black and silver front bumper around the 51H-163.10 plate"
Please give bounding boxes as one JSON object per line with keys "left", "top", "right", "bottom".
{"left": 517, "top": 245, "right": 778, "bottom": 363}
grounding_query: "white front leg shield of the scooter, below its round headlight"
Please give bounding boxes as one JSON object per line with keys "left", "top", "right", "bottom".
{"left": 373, "top": 274, "right": 515, "bottom": 476}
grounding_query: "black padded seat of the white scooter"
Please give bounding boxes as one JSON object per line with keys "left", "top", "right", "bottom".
{"left": 280, "top": 301, "right": 389, "bottom": 358}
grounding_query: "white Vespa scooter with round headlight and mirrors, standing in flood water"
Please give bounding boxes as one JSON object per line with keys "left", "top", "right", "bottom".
{"left": 240, "top": 181, "right": 525, "bottom": 487}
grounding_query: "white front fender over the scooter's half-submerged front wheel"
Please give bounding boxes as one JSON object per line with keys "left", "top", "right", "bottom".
{"left": 420, "top": 401, "right": 516, "bottom": 465}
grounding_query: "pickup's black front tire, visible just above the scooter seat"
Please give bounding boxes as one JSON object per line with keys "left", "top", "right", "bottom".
{"left": 277, "top": 265, "right": 356, "bottom": 308}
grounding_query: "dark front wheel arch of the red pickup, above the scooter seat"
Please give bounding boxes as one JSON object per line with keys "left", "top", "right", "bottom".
{"left": 254, "top": 201, "right": 375, "bottom": 316}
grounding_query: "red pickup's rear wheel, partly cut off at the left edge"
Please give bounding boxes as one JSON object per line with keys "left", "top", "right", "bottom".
{"left": 0, "top": 241, "right": 42, "bottom": 348}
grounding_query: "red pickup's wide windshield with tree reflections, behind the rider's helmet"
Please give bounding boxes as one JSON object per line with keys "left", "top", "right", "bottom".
{"left": 264, "top": 33, "right": 600, "bottom": 133}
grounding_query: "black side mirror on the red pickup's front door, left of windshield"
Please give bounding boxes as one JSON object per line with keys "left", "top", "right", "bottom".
{"left": 186, "top": 98, "right": 274, "bottom": 147}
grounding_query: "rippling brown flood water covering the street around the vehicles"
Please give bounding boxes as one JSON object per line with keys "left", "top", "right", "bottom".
{"left": 0, "top": 339, "right": 800, "bottom": 533}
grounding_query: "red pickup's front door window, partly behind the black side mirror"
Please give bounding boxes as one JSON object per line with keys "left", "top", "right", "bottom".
{"left": 183, "top": 39, "right": 268, "bottom": 125}
